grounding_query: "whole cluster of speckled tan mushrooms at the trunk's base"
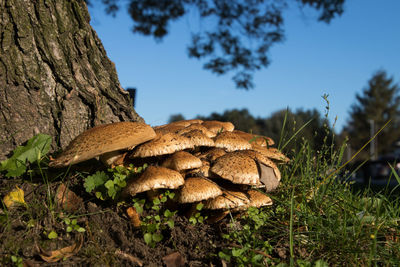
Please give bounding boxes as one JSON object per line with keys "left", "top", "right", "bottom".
{"left": 50, "top": 119, "right": 289, "bottom": 222}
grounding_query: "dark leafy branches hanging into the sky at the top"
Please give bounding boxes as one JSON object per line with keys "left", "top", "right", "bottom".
{"left": 95, "top": 0, "right": 345, "bottom": 89}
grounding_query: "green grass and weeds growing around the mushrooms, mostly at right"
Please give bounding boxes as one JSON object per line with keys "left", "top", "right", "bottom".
{"left": 0, "top": 117, "right": 400, "bottom": 266}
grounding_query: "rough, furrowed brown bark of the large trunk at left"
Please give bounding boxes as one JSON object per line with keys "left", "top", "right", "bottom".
{"left": 0, "top": 0, "right": 143, "bottom": 160}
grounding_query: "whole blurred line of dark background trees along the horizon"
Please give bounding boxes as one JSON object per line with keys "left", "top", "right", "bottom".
{"left": 170, "top": 70, "right": 400, "bottom": 160}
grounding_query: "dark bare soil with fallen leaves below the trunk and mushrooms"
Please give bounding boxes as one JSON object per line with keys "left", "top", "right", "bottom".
{"left": 0, "top": 172, "right": 238, "bottom": 266}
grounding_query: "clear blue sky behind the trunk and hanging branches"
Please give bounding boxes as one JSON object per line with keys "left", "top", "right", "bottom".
{"left": 89, "top": 0, "right": 400, "bottom": 131}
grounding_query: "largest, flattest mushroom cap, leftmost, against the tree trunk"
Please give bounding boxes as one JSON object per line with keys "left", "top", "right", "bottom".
{"left": 49, "top": 122, "right": 156, "bottom": 168}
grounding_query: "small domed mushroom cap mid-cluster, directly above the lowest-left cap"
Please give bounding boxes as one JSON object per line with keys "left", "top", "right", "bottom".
{"left": 161, "top": 151, "right": 203, "bottom": 171}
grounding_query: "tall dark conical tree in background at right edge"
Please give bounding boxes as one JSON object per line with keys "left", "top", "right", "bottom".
{"left": 344, "top": 70, "right": 400, "bottom": 159}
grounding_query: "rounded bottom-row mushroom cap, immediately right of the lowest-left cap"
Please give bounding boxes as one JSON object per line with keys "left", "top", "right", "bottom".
{"left": 178, "top": 177, "right": 222, "bottom": 203}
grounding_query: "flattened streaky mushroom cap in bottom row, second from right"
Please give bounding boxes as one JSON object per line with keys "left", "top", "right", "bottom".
{"left": 204, "top": 190, "right": 250, "bottom": 210}
